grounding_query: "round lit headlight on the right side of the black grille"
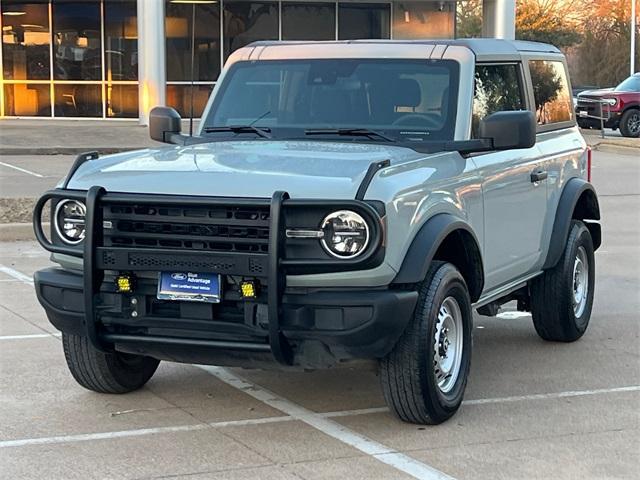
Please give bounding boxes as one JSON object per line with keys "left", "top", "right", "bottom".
{"left": 321, "top": 210, "right": 369, "bottom": 259}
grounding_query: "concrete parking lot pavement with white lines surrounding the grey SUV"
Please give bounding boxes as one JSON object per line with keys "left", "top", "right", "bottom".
{"left": 0, "top": 148, "right": 640, "bottom": 480}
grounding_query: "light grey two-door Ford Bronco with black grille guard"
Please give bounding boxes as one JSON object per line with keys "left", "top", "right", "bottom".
{"left": 34, "top": 39, "right": 601, "bottom": 424}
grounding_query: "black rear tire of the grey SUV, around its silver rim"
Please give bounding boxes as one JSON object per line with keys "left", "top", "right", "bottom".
{"left": 530, "top": 220, "right": 595, "bottom": 342}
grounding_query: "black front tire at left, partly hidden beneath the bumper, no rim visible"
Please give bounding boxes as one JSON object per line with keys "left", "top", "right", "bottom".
{"left": 62, "top": 333, "right": 160, "bottom": 393}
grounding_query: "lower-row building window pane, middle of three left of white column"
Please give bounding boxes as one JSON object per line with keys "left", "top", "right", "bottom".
{"left": 53, "top": 84, "right": 102, "bottom": 117}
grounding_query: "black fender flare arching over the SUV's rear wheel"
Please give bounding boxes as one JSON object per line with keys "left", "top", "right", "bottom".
{"left": 542, "top": 177, "right": 602, "bottom": 270}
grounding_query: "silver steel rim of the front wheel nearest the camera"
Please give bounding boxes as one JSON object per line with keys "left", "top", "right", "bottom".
{"left": 433, "top": 297, "right": 463, "bottom": 393}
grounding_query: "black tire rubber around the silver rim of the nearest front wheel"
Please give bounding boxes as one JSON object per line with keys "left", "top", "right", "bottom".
{"left": 380, "top": 262, "right": 473, "bottom": 425}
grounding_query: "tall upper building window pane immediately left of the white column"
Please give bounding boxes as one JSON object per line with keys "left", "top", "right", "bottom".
{"left": 104, "top": 0, "right": 138, "bottom": 81}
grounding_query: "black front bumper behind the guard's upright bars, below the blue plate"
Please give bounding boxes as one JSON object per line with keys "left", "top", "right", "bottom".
{"left": 35, "top": 268, "right": 418, "bottom": 368}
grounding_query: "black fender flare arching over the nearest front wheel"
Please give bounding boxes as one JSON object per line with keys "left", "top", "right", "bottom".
{"left": 392, "top": 213, "right": 484, "bottom": 301}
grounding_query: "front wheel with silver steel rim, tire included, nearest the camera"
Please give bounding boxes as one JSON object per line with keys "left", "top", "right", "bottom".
{"left": 380, "top": 262, "right": 472, "bottom": 425}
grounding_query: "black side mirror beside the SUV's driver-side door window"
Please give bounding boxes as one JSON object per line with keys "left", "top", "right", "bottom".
{"left": 478, "top": 110, "right": 536, "bottom": 150}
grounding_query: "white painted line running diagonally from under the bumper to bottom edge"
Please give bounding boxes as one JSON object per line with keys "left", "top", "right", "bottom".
{"left": 200, "top": 365, "right": 453, "bottom": 480}
